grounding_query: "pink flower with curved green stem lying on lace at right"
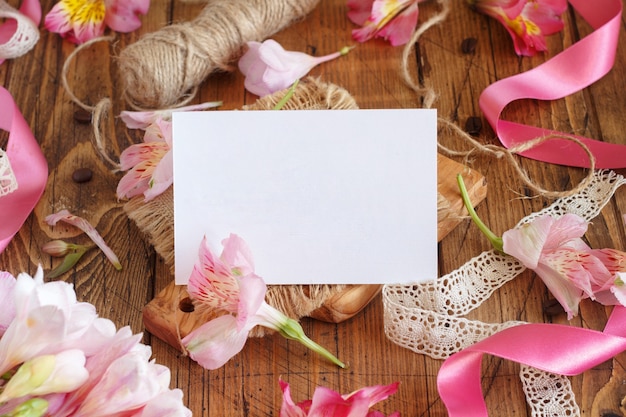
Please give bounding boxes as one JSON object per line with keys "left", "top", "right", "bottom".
{"left": 457, "top": 176, "right": 626, "bottom": 319}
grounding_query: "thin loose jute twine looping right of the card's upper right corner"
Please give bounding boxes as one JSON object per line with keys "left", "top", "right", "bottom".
{"left": 400, "top": 0, "right": 596, "bottom": 198}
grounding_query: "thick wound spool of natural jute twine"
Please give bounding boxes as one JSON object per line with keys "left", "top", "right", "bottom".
{"left": 119, "top": 0, "right": 319, "bottom": 109}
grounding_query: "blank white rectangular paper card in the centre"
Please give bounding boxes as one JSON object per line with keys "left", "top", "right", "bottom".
{"left": 173, "top": 109, "right": 437, "bottom": 284}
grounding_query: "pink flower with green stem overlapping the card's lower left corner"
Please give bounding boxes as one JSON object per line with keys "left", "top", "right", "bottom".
{"left": 182, "top": 234, "right": 345, "bottom": 369}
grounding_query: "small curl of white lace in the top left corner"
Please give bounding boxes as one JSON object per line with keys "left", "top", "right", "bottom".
{"left": 0, "top": 0, "right": 39, "bottom": 59}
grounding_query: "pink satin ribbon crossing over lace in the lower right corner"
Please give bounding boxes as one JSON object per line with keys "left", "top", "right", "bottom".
{"left": 437, "top": 306, "right": 626, "bottom": 417}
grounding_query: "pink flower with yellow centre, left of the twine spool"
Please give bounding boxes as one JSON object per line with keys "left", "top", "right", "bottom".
{"left": 44, "top": 0, "right": 150, "bottom": 44}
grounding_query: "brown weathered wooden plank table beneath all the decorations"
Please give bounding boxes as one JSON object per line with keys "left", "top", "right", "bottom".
{"left": 0, "top": 0, "right": 626, "bottom": 417}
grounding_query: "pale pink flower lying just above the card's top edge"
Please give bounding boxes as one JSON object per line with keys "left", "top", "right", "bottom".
{"left": 239, "top": 39, "right": 350, "bottom": 97}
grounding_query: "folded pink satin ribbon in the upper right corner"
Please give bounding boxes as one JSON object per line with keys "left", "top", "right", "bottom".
{"left": 479, "top": 0, "right": 626, "bottom": 168}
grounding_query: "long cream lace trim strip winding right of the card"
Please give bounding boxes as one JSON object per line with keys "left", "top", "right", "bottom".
{"left": 383, "top": 171, "right": 626, "bottom": 417}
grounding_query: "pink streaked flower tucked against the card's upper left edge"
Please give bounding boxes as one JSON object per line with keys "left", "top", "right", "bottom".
{"left": 117, "top": 117, "right": 174, "bottom": 201}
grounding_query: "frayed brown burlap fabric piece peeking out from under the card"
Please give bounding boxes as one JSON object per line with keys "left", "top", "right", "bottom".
{"left": 124, "top": 77, "right": 381, "bottom": 324}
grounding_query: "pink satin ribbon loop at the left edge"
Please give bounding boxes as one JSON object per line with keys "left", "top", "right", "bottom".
{"left": 0, "top": 87, "right": 48, "bottom": 253}
